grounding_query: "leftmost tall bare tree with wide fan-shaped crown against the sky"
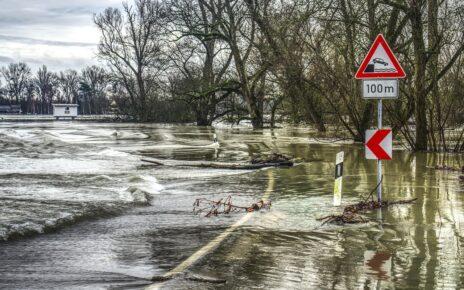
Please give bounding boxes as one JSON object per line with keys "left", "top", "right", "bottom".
{"left": 94, "top": 0, "right": 166, "bottom": 121}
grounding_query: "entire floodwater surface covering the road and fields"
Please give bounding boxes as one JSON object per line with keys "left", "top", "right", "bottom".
{"left": 0, "top": 122, "right": 464, "bottom": 289}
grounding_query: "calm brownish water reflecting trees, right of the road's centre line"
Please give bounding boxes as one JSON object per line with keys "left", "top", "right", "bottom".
{"left": 161, "top": 135, "right": 463, "bottom": 289}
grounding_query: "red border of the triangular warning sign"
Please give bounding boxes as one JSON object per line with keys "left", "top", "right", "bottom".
{"left": 355, "top": 34, "right": 406, "bottom": 80}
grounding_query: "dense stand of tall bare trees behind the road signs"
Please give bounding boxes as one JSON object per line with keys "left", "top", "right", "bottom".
{"left": 94, "top": 0, "right": 464, "bottom": 151}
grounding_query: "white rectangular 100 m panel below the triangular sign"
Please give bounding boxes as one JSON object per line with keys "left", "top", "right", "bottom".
{"left": 363, "top": 79, "right": 398, "bottom": 99}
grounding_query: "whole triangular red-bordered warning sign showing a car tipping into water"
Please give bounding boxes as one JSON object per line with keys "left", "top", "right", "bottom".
{"left": 355, "top": 34, "right": 406, "bottom": 79}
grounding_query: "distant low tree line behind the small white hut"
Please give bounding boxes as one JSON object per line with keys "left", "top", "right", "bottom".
{"left": 0, "top": 62, "right": 113, "bottom": 114}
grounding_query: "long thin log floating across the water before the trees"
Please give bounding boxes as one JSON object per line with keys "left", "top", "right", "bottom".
{"left": 142, "top": 157, "right": 293, "bottom": 170}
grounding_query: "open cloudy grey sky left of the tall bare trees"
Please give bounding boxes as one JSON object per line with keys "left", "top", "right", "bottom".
{"left": 0, "top": 0, "right": 121, "bottom": 71}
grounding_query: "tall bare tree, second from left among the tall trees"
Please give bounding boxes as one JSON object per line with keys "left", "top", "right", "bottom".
{"left": 170, "top": 0, "right": 236, "bottom": 126}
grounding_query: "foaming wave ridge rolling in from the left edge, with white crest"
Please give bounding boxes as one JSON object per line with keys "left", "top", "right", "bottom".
{"left": 0, "top": 175, "right": 163, "bottom": 241}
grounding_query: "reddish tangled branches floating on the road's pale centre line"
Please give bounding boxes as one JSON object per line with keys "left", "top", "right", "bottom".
{"left": 193, "top": 195, "right": 271, "bottom": 217}
